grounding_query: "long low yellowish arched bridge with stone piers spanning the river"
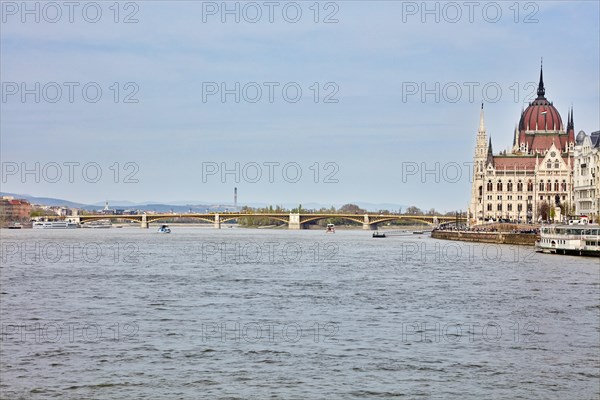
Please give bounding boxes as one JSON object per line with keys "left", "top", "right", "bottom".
{"left": 67, "top": 212, "right": 466, "bottom": 230}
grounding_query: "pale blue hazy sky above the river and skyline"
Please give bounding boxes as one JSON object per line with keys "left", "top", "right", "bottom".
{"left": 0, "top": 0, "right": 600, "bottom": 211}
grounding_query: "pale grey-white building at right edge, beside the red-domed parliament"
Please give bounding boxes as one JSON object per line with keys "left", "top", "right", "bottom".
{"left": 574, "top": 131, "right": 600, "bottom": 222}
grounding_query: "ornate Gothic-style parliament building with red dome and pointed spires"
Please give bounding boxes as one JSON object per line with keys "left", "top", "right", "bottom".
{"left": 469, "top": 64, "right": 575, "bottom": 223}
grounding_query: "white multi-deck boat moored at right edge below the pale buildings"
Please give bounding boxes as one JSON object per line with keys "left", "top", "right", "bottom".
{"left": 535, "top": 224, "right": 600, "bottom": 257}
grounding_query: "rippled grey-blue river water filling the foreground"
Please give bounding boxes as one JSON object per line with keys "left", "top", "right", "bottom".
{"left": 0, "top": 227, "right": 600, "bottom": 399}
